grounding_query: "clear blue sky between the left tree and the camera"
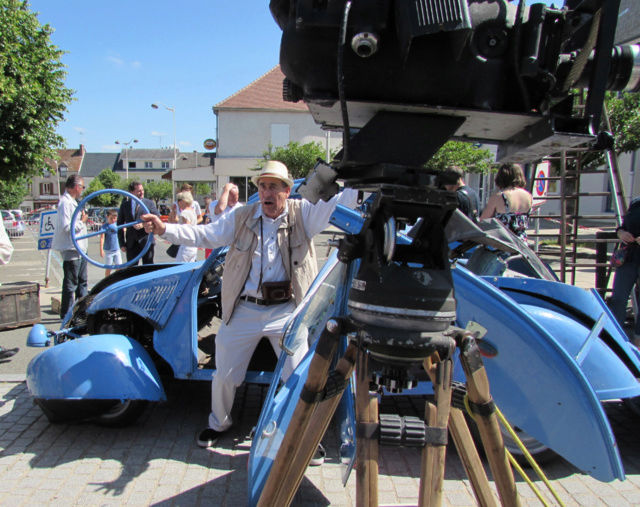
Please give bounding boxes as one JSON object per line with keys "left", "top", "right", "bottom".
{"left": 29, "top": 0, "right": 562, "bottom": 152}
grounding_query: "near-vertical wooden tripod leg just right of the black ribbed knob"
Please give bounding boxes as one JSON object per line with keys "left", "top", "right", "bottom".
{"left": 419, "top": 353, "right": 452, "bottom": 507}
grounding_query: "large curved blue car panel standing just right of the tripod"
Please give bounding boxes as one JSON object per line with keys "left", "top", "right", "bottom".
{"left": 452, "top": 266, "right": 624, "bottom": 481}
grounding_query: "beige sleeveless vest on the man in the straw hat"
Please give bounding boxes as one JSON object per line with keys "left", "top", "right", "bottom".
{"left": 222, "top": 199, "right": 318, "bottom": 324}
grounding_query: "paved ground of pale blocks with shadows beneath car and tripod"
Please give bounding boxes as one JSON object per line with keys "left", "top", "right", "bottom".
{"left": 0, "top": 228, "right": 640, "bottom": 506}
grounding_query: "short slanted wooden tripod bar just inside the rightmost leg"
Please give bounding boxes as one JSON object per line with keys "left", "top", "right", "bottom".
{"left": 449, "top": 408, "right": 496, "bottom": 507}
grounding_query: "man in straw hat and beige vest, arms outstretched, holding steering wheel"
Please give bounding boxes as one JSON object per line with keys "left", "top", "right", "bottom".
{"left": 142, "top": 160, "right": 357, "bottom": 447}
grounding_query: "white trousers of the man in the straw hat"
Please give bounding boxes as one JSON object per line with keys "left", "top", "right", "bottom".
{"left": 209, "top": 301, "right": 308, "bottom": 431}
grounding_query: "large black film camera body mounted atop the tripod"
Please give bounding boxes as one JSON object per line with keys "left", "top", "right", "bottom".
{"left": 271, "top": 0, "right": 640, "bottom": 164}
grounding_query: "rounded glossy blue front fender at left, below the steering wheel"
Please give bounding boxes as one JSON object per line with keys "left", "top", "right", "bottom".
{"left": 27, "top": 334, "right": 166, "bottom": 401}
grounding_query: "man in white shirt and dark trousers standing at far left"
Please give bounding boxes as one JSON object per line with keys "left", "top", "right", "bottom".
{"left": 51, "top": 174, "right": 88, "bottom": 319}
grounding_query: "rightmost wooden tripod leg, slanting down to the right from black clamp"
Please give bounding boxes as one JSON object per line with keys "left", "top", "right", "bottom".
{"left": 460, "top": 336, "right": 520, "bottom": 506}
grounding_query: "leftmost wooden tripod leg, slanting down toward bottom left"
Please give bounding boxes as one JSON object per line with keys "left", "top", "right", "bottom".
{"left": 258, "top": 321, "right": 340, "bottom": 507}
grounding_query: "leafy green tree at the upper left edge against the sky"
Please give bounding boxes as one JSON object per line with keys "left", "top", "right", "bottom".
{"left": 0, "top": 0, "right": 72, "bottom": 181}
